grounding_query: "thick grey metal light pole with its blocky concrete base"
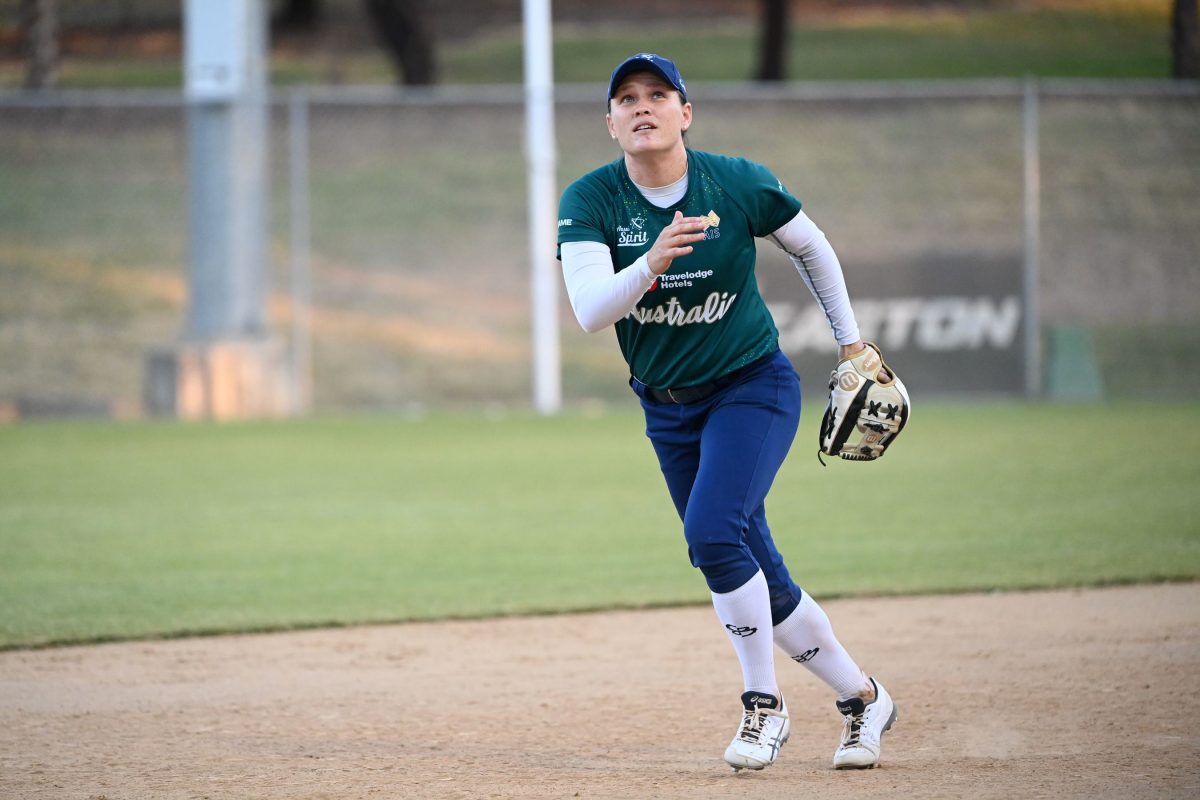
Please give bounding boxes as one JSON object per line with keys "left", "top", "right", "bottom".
{"left": 145, "top": 0, "right": 296, "bottom": 419}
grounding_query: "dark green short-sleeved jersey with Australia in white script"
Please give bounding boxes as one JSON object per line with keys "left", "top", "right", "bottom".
{"left": 558, "top": 150, "right": 800, "bottom": 389}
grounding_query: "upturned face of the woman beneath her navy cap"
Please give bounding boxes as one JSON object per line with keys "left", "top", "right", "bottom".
{"left": 606, "top": 72, "right": 691, "bottom": 156}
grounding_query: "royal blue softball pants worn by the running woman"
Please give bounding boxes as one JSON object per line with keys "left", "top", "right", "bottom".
{"left": 630, "top": 350, "right": 800, "bottom": 625}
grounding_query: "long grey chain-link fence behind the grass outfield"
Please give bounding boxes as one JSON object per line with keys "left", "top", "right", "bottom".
{"left": 0, "top": 82, "right": 1200, "bottom": 415}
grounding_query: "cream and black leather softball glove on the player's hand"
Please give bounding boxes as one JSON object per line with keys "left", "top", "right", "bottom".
{"left": 817, "top": 342, "right": 908, "bottom": 464}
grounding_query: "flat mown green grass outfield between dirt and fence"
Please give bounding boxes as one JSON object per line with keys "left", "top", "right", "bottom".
{"left": 0, "top": 404, "right": 1200, "bottom": 648}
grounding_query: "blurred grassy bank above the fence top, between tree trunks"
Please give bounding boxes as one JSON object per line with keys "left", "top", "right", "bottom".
{"left": 0, "top": 0, "right": 1170, "bottom": 89}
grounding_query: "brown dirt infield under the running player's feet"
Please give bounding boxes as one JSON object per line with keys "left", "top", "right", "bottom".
{"left": 0, "top": 584, "right": 1200, "bottom": 800}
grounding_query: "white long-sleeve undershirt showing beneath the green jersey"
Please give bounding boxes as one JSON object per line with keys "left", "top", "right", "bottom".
{"left": 562, "top": 206, "right": 859, "bottom": 344}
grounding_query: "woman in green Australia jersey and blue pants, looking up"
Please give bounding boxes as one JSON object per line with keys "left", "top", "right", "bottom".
{"left": 558, "top": 53, "right": 896, "bottom": 770}
